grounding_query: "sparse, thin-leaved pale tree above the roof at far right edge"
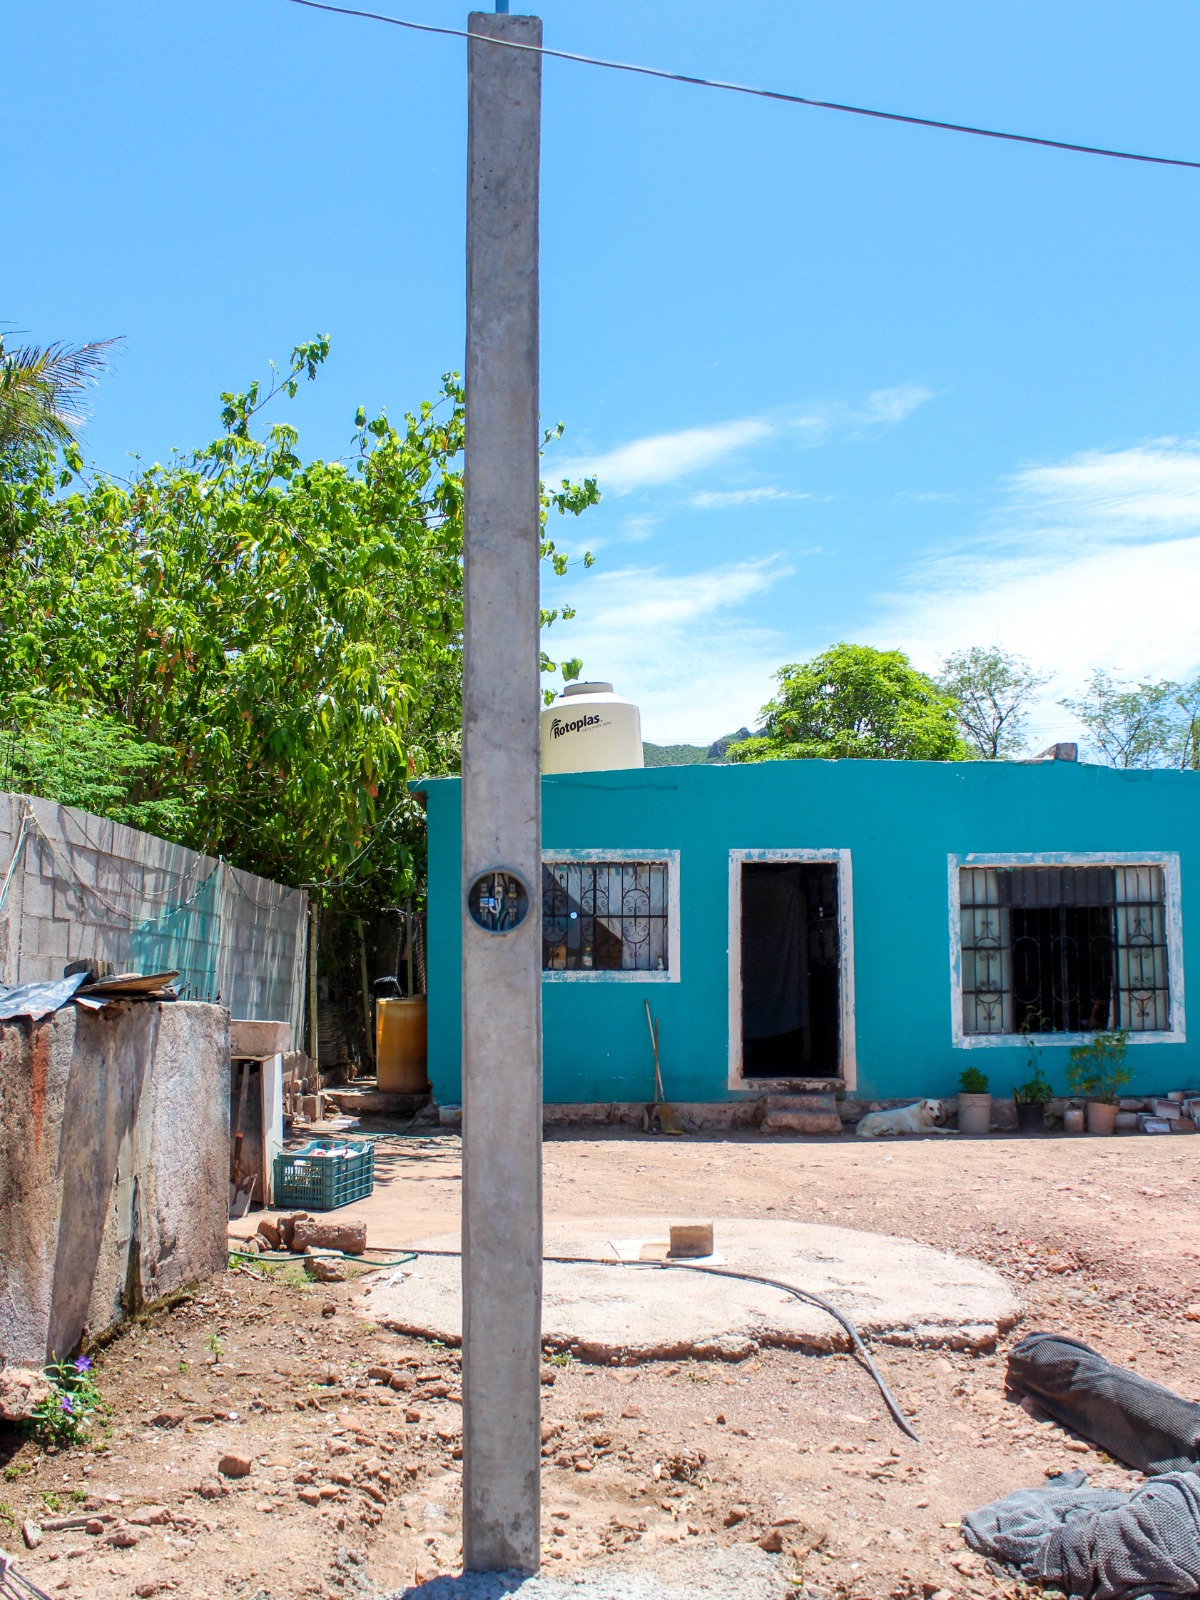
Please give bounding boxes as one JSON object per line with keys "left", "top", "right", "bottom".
{"left": 1059, "top": 670, "right": 1200, "bottom": 768}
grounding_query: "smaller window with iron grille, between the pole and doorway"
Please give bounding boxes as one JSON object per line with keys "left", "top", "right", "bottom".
{"left": 542, "top": 861, "right": 670, "bottom": 973}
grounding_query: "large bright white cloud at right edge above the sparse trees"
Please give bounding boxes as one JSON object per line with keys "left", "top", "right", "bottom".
{"left": 880, "top": 442, "right": 1200, "bottom": 742}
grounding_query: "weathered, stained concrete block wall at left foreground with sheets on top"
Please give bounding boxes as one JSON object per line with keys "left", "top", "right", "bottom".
{"left": 0, "top": 1000, "right": 229, "bottom": 1366}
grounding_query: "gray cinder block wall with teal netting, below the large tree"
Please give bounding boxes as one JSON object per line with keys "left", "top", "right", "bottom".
{"left": 0, "top": 792, "right": 307, "bottom": 1045}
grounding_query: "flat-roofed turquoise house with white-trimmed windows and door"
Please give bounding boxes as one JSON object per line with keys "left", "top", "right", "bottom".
{"left": 418, "top": 760, "right": 1200, "bottom": 1104}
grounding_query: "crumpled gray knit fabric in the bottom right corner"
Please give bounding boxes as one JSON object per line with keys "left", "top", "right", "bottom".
{"left": 963, "top": 1472, "right": 1200, "bottom": 1600}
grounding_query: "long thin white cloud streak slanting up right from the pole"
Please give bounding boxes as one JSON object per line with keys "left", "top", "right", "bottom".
{"left": 546, "top": 384, "right": 933, "bottom": 494}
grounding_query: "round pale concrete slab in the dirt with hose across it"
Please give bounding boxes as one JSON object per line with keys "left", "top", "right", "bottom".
{"left": 358, "top": 1216, "right": 1021, "bottom": 1363}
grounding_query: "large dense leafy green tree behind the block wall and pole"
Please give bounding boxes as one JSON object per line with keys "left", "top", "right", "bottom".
{"left": 0, "top": 339, "right": 598, "bottom": 906}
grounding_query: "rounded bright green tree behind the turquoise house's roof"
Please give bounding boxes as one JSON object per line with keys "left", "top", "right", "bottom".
{"left": 728, "top": 645, "right": 968, "bottom": 762}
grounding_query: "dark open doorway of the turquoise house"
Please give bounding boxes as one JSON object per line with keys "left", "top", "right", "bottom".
{"left": 742, "top": 861, "right": 842, "bottom": 1078}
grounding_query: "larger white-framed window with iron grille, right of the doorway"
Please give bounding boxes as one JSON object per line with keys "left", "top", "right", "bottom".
{"left": 958, "top": 864, "right": 1171, "bottom": 1035}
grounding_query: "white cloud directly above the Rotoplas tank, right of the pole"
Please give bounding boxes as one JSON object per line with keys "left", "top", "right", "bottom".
{"left": 546, "top": 557, "right": 790, "bottom": 744}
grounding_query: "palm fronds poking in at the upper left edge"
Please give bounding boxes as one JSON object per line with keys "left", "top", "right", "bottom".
{"left": 0, "top": 334, "right": 117, "bottom": 456}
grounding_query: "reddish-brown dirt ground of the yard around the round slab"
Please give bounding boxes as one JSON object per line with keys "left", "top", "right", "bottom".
{"left": 0, "top": 1131, "right": 1200, "bottom": 1600}
